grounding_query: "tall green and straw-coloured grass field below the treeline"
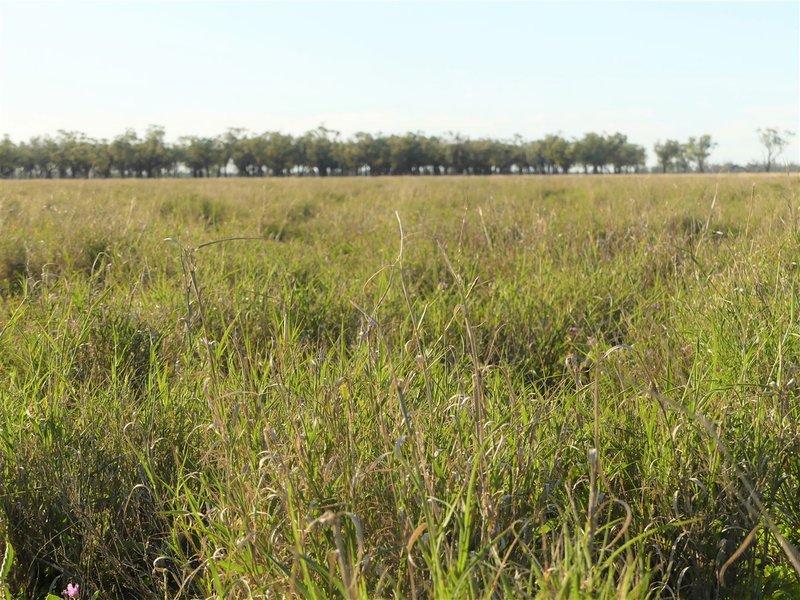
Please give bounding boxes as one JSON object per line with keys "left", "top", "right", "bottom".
{"left": 0, "top": 175, "right": 800, "bottom": 599}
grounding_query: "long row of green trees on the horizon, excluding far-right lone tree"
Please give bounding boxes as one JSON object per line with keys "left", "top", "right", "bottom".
{"left": 0, "top": 126, "right": 714, "bottom": 178}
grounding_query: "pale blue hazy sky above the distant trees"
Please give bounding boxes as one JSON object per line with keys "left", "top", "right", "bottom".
{"left": 0, "top": 0, "right": 800, "bottom": 164}
